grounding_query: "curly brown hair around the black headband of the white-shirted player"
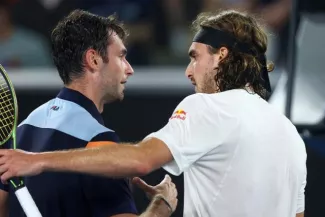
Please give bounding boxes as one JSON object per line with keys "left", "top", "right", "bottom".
{"left": 192, "top": 10, "right": 273, "bottom": 99}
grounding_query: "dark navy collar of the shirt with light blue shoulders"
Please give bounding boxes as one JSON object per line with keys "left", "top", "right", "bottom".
{"left": 57, "top": 87, "right": 104, "bottom": 125}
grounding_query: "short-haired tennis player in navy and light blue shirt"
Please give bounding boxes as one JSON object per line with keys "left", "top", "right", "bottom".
{"left": 0, "top": 10, "right": 177, "bottom": 217}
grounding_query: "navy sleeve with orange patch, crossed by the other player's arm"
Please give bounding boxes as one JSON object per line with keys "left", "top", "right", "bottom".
{"left": 81, "top": 131, "right": 137, "bottom": 217}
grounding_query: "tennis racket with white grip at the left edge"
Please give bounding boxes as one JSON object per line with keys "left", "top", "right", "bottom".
{"left": 0, "top": 64, "right": 42, "bottom": 217}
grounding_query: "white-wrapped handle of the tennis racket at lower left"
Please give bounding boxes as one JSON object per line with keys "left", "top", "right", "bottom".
{"left": 15, "top": 186, "right": 42, "bottom": 217}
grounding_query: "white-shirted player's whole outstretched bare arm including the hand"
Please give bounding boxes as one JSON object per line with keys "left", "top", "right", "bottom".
{"left": 0, "top": 138, "right": 173, "bottom": 181}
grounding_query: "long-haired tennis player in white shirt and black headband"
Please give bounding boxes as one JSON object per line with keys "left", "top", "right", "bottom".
{"left": 0, "top": 11, "right": 306, "bottom": 217}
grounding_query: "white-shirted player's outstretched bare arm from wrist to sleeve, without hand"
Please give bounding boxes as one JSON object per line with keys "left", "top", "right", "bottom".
{"left": 39, "top": 139, "right": 172, "bottom": 177}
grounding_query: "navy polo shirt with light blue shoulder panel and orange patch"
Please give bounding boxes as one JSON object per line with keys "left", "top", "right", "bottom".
{"left": 0, "top": 88, "right": 137, "bottom": 217}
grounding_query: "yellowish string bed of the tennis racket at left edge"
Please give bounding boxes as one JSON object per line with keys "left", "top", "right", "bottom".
{"left": 0, "top": 76, "right": 15, "bottom": 140}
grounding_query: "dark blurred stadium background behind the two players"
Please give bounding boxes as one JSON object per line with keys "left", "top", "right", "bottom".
{"left": 0, "top": 0, "right": 325, "bottom": 217}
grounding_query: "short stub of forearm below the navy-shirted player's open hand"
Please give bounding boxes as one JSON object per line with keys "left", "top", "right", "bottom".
{"left": 139, "top": 197, "right": 172, "bottom": 217}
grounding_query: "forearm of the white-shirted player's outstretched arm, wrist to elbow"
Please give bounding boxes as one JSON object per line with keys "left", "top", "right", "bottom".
{"left": 36, "top": 144, "right": 148, "bottom": 177}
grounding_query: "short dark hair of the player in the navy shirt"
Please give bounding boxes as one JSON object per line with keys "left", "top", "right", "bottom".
{"left": 51, "top": 9, "right": 127, "bottom": 84}
